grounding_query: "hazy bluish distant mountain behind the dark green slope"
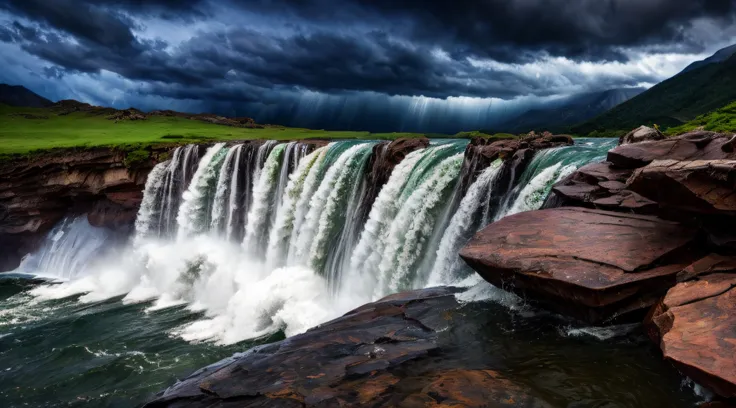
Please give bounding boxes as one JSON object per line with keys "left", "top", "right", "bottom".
{"left": 496, "top": 88, "right": 646, "bottom": 133}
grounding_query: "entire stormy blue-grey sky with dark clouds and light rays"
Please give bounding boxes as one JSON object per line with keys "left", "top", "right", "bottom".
{"left": 0, "top": 0, "right": 736, "bottom": 132}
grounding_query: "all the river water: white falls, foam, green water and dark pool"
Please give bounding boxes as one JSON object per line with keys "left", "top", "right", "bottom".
{"left": 0, "top": 140, "right": 697, "bottom": 407}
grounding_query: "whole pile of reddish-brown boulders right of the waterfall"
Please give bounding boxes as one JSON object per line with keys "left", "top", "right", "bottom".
{"left": 461, "top": 132, "right": 736, "bottom": 399}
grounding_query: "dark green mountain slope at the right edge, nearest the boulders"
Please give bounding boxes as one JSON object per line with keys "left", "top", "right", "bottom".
{"left": 571, "top": 50, "right": 736, "bottom": 136}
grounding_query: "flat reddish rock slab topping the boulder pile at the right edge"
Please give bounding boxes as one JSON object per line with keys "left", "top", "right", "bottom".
{"left": 608, "top": 131, "right": 736, "bottom": 169}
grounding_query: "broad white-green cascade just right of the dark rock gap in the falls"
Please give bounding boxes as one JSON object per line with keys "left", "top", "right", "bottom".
{"left": 349, "top": 143, "right": 465, "bottom": 298}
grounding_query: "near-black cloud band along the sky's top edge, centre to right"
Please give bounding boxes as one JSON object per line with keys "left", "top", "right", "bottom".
{"left": 235, "top": 0, "right": 736, "bottom": 62}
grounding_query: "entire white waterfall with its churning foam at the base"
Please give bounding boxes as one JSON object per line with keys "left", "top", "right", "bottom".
{"left": 23, "top": 140, "right": 614, "bottom": 344}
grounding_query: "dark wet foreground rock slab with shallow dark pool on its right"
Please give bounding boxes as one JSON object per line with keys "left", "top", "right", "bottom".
{"left": 146, "top": 288, "right": 695, "bottom": 408}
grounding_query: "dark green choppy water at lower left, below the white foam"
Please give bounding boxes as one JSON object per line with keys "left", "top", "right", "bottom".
{"left": 0, "top": 278, "right": 283, "bottom": 408}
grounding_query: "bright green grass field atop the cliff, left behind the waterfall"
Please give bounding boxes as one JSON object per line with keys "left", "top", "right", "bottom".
{"left": 0, "top": 105, "right": 424, "bottom": 158}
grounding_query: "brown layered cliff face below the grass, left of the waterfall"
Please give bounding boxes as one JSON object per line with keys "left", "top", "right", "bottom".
{"left": 0, "top": 148, "right": 170, "bottom": 271}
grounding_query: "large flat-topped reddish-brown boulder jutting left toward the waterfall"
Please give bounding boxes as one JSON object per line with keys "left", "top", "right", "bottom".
{"left": 460, "top": 208, "right": 695, "bottom": 322}
